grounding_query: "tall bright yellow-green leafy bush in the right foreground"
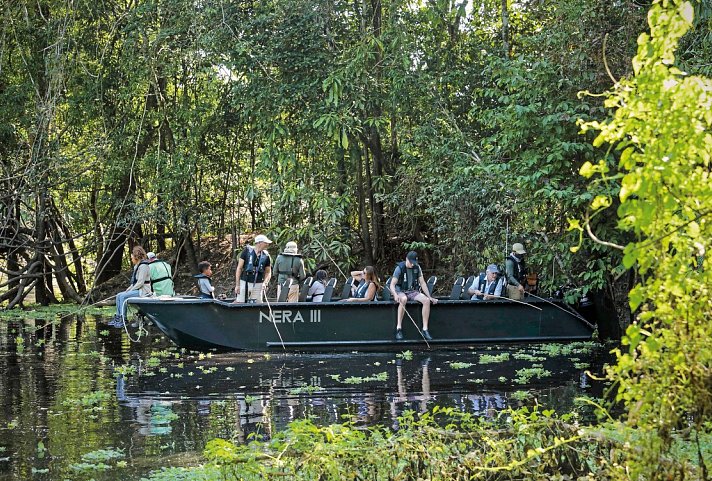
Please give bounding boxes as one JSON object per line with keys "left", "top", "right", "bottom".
{"left": 582, "top": 0, "right": 712, "bottom": 479}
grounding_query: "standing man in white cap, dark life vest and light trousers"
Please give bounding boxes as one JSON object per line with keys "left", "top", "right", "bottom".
{"left": 234, "top": 234, "right": 272, "bottom": 302}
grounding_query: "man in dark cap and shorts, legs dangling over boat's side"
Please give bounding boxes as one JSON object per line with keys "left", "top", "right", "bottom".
{"left": 389, "top": 251, "right": 438, "bottom": 341}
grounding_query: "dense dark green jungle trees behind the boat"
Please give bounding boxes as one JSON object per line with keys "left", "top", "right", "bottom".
{"left": 0, "top": 0, "right": 711, "bottom": 307}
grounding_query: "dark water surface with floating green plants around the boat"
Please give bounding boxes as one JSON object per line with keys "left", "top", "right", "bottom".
{"left": 0, "top": 316, "right": 607, "bottom": 481}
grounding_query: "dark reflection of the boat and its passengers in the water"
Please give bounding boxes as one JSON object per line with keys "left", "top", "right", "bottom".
{"left": 117, "top": 345, "right": 602, "bottom": 440}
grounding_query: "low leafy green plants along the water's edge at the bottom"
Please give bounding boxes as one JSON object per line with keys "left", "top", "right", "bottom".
{"left": 186, "top": 407, "right": 710, "bottom": 481}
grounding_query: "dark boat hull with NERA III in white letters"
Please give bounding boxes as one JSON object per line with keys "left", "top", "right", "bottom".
{"left": 128, "top": 296, "right": 595, "bottom": 351}
